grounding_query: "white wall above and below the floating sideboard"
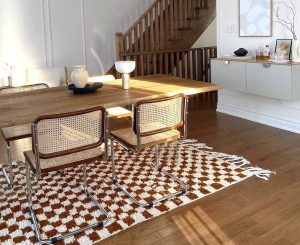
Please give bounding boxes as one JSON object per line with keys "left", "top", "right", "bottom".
{"left": 217, "top": 0, "right": 300, "bottom": 133}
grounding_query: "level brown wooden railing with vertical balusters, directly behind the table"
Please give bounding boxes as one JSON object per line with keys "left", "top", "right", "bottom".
{"left": 120, "top": 47, "right": 217, "bottom": 83}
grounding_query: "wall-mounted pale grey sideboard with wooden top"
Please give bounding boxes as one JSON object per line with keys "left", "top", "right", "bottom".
{"left": 211, "top": 58, "right": 300, "bottom": 101}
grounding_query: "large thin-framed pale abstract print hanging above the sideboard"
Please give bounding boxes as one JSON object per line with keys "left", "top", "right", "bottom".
{"left": 239, "top": 0, "right": 273, "bottom": 37}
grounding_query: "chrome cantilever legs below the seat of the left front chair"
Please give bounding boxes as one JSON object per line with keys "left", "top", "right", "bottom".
{"left": 25, "top": 162, "right": 109, "bottom": 244}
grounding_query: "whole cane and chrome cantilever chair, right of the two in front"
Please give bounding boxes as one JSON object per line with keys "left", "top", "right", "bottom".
{"left": 111, "top": 94, "right": 189, "bottom": 207}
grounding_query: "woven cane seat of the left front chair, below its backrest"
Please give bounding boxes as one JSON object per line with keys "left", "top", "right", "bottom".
{"left": 24, "top": 148, "right": 103, "bottom": 173}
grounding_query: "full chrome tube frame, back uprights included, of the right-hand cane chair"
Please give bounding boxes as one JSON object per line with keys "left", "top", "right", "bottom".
{"left": 111, "top": 97, "right": 189, "bottom": 207}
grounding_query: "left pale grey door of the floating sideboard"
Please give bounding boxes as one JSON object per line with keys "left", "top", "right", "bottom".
{"left": 211, "top": 60, "right": 246, "bottom": 92}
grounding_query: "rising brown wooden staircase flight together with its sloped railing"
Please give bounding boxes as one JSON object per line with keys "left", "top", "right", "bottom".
{"left": 116, "top": 0, "right": 216, "bottom": 56}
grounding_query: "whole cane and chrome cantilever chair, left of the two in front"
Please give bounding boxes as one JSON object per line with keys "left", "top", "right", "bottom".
{"left": 24, "top": 106, "right": 109, "bottom": 244}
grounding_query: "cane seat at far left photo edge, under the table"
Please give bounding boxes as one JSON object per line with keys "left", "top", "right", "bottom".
{"left": 1, "top": 123, "right": 31, "bottom": 141}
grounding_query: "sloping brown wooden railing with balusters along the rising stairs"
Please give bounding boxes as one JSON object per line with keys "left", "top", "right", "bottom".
{"left": 116, "top": 0, "right": 208, "bottom": 60}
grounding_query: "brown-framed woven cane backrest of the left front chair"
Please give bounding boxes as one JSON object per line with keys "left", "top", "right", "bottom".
{"left": 32, "top": 107, "right": 106, "bottom": 158}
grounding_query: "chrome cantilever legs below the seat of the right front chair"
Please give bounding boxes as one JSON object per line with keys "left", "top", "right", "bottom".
{"left": 111, "top": 137, "right": 189, "bottom": 207}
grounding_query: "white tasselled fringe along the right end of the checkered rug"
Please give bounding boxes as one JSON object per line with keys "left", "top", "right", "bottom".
{"left": 180, "top": 139, "right": 276, "bottom": 180}
